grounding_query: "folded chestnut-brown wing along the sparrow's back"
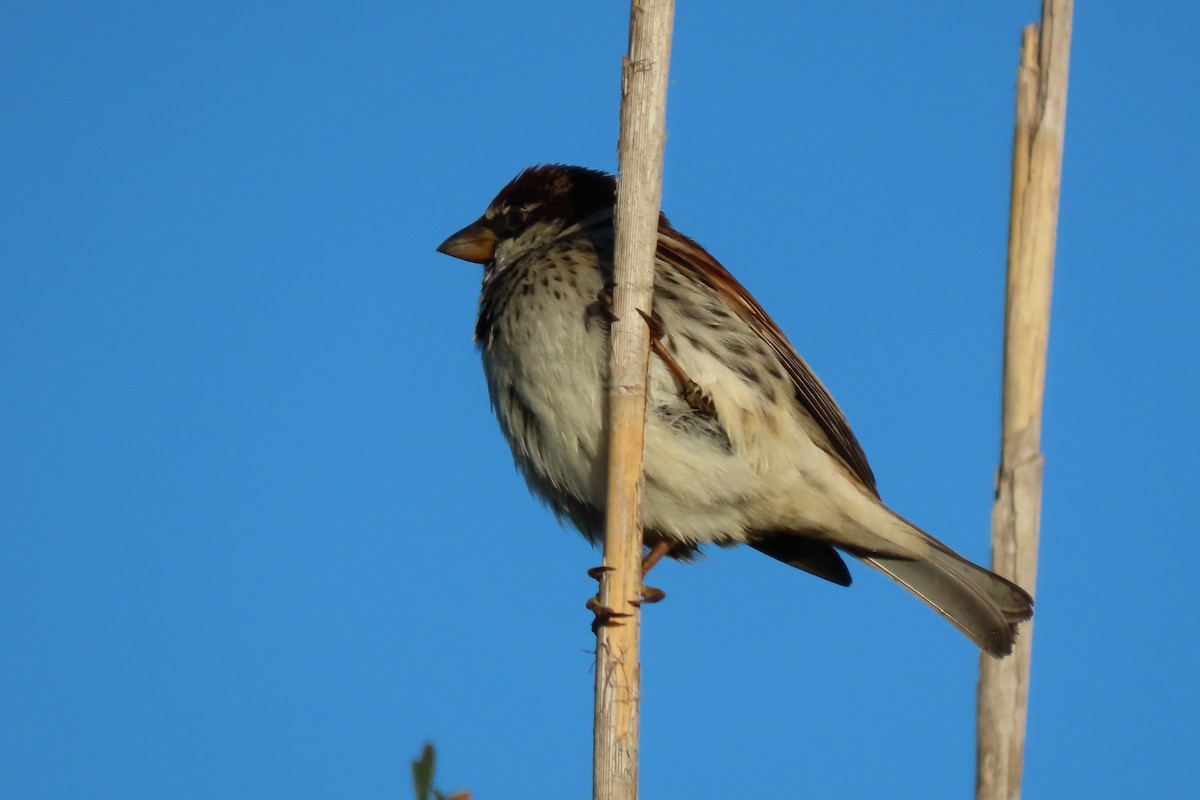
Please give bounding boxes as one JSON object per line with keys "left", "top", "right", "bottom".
{"left": 658, "top": 224, "right": 878, "bottom": 497}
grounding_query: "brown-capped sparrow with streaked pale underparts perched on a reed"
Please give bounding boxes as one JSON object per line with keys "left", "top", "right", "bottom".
{"left": 438, "top": 164, "right": 1033, "bottom": 657}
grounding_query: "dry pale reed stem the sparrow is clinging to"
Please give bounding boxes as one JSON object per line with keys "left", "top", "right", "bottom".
{"left": 592, "top": 0, "right": 674, "bottom": 800}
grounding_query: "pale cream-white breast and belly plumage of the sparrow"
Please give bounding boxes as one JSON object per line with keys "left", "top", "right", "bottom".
{"left": 480, "top": 224, "right": 928, "bottom": 557}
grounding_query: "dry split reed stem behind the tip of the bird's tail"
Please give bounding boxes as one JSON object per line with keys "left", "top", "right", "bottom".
{"left": 976, "top": 0, "right": 1073, "bottom": 800}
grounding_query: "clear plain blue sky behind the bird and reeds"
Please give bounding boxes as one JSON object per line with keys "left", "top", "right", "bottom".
{"left": 0, "top": 0, "right": 1200, "bottom": 799}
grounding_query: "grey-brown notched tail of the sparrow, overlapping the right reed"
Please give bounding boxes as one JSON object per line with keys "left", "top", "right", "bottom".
{"left": 863, "top": 527, "right": 1033, "bottom": 658}
